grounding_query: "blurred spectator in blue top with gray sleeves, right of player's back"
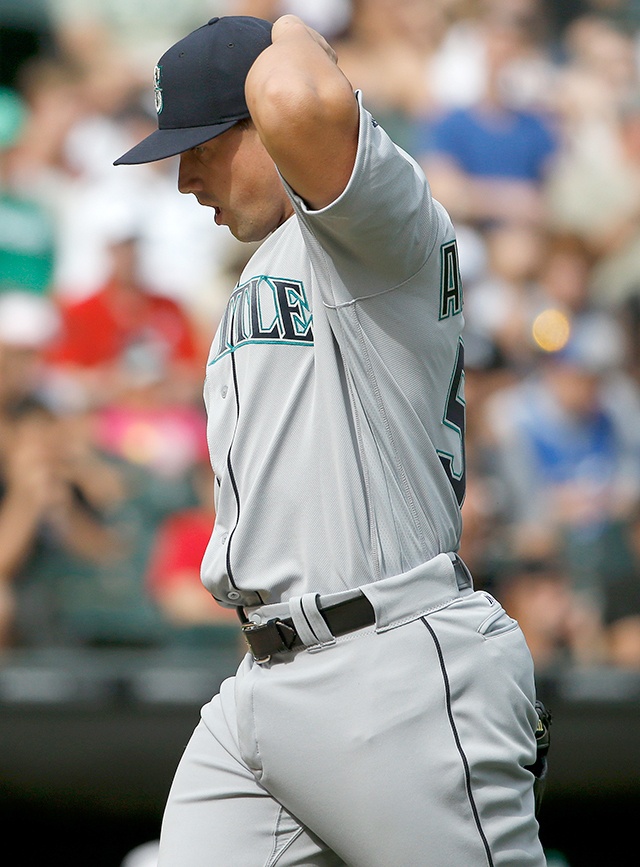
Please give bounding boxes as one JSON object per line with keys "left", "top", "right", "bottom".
{"left": 487, "top": 312, "right": 640, "bottom": 628}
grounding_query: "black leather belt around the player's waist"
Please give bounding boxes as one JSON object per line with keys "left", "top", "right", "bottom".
{"left": 240, "top": 557, "right": 472, "bottom": 663}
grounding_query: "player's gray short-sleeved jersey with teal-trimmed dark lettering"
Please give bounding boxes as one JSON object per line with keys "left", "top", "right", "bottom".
{"left": 202, "top": 91, "right": 464, "bottom": 606}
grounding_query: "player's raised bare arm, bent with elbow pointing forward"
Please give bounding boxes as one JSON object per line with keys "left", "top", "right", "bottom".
{"left": 245, "top": 15, "right": 358, "bottom": 209}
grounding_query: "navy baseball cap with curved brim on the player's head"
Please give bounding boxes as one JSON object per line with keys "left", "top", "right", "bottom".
{"left": 114, "top": 15, "right": 272, "bottom": 166}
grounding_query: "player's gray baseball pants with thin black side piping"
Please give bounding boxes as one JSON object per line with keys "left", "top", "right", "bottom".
{"left": 159, "top": 555, "right": 546, "bottom": 867}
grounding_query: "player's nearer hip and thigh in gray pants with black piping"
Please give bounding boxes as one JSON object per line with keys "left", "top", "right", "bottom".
{"left": 222, "top": 592, "right": 542, "bottom": 867}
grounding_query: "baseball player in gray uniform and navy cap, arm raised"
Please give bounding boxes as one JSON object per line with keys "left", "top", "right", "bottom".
{"left": 117, "top": 15, "right": 545, "bottom": 867}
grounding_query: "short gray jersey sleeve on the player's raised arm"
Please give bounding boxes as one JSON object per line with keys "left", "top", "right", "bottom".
{"left": 285, "top": 92, "right": 453, "bottom": 305}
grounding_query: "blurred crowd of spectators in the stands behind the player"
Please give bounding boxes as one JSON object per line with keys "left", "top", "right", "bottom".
{"left": 0, "top": 0, "right": 640, "bottom": 669}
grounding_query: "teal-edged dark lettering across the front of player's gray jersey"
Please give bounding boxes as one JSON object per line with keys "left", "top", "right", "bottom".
{"left": 209, "top": 275, "right": 313, "bottom": 364}
